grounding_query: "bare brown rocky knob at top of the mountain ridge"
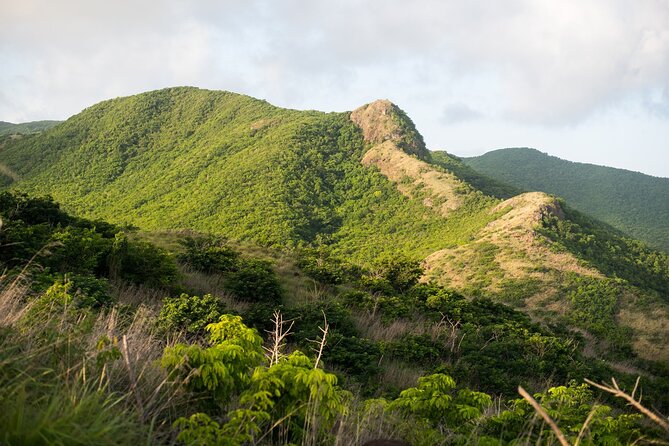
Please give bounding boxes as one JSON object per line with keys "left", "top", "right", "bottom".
{"left": 351, "top": 99, "right": 430, "bottom": 160}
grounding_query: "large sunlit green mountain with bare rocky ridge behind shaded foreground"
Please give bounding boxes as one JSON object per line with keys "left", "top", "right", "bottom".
{"left": 0, "top": 88, "right": 669, "bottom": 366}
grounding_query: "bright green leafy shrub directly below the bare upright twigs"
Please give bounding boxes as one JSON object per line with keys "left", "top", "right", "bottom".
{"left": 175, "top": 352, "right": 349, "bottom": 446}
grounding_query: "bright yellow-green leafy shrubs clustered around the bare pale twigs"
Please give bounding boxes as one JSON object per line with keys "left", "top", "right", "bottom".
{"left": 162, "top": 315, "right": 349, "bottom": 445}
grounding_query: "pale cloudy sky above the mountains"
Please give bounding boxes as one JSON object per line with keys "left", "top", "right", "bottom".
{"left": 0, "top": 0, "right": 669, "bottom": 177}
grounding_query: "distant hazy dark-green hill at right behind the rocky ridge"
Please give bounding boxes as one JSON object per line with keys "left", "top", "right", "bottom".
{"left": 462, "top": 148, "right": 669, "bottom": 252}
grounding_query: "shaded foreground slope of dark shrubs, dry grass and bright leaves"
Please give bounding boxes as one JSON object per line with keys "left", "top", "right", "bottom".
{"left": 0, "top": 193, "right": 669, "bottom": 445}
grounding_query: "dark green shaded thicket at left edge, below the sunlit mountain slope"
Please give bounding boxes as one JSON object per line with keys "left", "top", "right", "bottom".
{"left": 0, "top": 192, "right": 177, "bottom": 292}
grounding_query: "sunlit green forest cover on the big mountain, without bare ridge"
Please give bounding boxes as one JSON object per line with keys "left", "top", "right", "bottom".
{"left": 0, "top": 88, "right": 495, "bottom": 264}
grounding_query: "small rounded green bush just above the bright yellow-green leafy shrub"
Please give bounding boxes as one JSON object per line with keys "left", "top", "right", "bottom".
{"left": 158, "top": 294, "right": 225, "bottom": 334}
